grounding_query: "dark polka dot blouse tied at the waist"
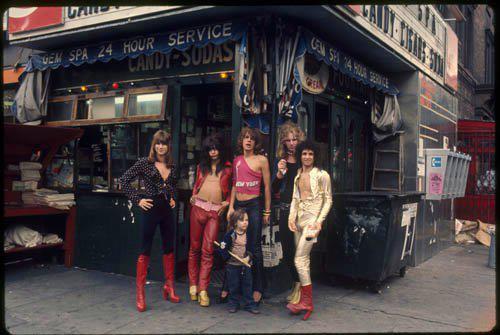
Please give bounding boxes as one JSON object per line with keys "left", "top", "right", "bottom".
{"left": 120, "top": 158, "right": 178, "bottom": 205}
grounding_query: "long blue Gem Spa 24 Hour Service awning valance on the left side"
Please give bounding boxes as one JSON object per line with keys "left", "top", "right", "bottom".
{"left": 26, "top": 21, "right": 247, "bottom": 72}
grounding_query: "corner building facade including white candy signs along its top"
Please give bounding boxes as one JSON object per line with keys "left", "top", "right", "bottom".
{"left": 4, "top": 5, "right": 464, "bottom": 288}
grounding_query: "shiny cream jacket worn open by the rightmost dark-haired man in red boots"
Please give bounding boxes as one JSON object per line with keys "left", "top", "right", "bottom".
{"left": 288, "top": 167, "right": 332, "bottom": 228}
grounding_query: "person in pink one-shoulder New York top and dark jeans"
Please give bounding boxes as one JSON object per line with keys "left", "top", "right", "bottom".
{"left": 226, "top": 127, "right": 271, "bottom": 302}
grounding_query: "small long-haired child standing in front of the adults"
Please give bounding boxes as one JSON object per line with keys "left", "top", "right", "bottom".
{"left": 220, "top": 208, "right": 260, "bottom": 314}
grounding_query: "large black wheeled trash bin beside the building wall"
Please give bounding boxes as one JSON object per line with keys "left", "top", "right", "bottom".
{"left": 325, "top": 192, "right": 423, "bottom": 292}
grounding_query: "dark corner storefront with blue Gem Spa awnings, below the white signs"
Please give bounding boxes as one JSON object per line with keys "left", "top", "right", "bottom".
{"left": 6, "top": 6, "right": 456, "bottom": 288}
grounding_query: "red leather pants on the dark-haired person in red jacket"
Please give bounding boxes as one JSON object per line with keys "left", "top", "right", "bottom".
{"left": 188, "top": 206, "right": 219, "bottom": 292}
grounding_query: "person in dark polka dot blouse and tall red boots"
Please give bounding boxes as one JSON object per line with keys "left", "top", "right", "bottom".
{"left": 120, "top": 130, "right": 180, "bottom": 312}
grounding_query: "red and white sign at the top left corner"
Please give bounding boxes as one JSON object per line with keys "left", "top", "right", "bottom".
{"left": 8, "top": 7, "right": 64, "bottom": 34}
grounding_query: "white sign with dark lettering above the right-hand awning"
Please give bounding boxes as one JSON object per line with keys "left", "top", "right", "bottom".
{"left": 338, "top": 5, "right": 454, "bottom": 88}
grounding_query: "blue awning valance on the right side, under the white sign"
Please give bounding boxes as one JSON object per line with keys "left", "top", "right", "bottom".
{"left": 296, "top": 28, "right": 399, "bottom": 95}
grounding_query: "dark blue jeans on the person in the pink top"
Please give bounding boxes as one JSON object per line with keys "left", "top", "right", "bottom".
{"left": 234, "top": 198, "right": 264, "bottom": 293}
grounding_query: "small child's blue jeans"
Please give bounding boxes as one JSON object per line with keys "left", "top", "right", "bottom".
{"left": 226, "top": 264, "right": 257, "bottom": 309}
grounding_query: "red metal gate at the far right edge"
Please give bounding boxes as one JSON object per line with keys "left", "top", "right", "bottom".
{"left": 455, "top": 120, "right": 496, "bottom": 224}
